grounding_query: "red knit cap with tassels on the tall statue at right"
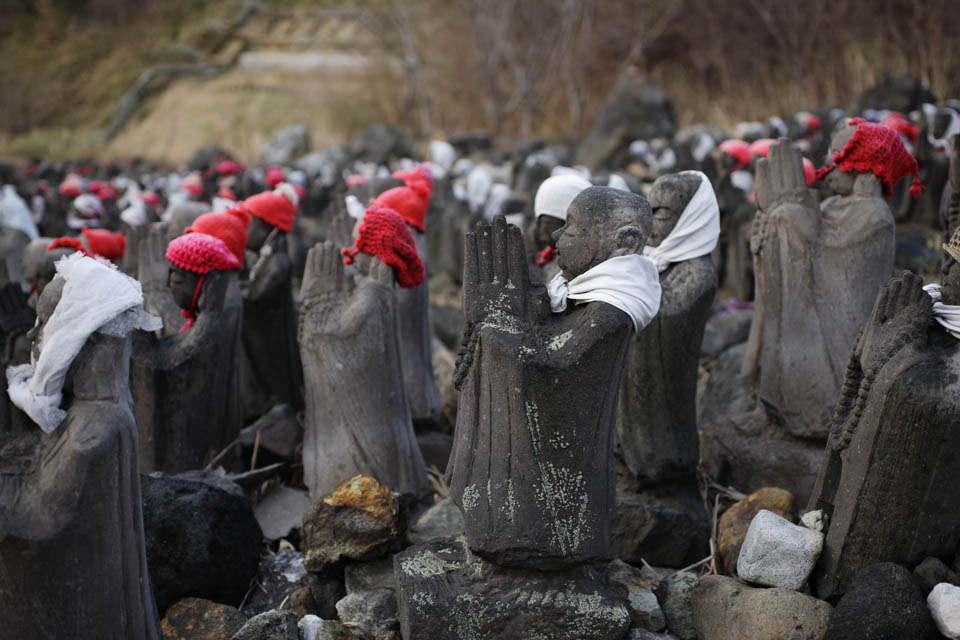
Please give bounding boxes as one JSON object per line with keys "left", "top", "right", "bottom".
{"left": 817, "top": 118, "right": 923, "bottom": 198}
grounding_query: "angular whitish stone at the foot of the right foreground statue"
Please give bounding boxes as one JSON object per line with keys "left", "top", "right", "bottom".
{"left": 737, "top": 509, "right": 823, "bottom": 591}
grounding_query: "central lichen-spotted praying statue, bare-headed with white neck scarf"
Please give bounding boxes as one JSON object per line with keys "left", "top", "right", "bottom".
{"left": 448, "top": 187, "right": 660, "bottom": 569}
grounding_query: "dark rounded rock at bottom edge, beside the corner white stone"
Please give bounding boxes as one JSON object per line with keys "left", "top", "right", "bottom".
{"left": 824, "top": 562, "right": 939, "bottom": 640}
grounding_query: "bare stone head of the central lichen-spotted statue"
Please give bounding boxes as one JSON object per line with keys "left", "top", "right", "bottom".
{"left": 554, "top": 187, "right": 653, "bottom": 280}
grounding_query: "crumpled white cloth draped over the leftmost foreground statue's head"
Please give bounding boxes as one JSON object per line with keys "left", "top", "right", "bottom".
{"left": 7, "top": 252, "right": 162, "bottom": 433}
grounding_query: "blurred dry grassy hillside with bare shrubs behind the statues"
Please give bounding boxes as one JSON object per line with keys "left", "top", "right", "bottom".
{"left": 0, "top": 0, "right": 960, "bottom": 164}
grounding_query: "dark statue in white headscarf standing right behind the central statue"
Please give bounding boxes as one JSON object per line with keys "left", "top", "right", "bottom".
{"left": 617, "top": 171, "right": 720, "bottom": 485}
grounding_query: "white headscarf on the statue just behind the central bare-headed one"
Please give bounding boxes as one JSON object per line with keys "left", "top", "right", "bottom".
{"left": 643, "top": 171, "right": 720, "bottom": 271}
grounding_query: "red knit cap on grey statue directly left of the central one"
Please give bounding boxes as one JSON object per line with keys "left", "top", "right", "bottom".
{"left": 343, "top": 204, "right": 426, "bottom": 289}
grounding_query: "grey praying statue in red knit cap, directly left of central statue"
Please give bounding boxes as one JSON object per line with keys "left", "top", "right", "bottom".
{"left": 299, "top": 206, "right": 427, "bottom": 497}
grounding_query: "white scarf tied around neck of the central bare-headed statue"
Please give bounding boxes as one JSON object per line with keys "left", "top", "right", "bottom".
{"left": 547, "top": 253, "right": 660, "bottom": 331}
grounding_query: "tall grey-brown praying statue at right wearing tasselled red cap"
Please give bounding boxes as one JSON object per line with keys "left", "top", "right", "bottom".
{"left": 743, "top": 119, "right": 900, "bottom": 440}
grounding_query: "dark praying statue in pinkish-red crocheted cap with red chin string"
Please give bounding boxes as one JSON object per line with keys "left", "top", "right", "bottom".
{"left": 131, "top": 224, "right": 245, "bottom": 472}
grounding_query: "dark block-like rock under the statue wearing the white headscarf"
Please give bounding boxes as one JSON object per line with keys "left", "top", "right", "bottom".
{"left": 611, "top": 483, "right": 710, "bottom": 567}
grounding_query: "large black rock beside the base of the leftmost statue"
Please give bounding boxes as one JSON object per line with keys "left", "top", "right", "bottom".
{"left": 140, "top": 471, "right": 263, "bottom": 613}
